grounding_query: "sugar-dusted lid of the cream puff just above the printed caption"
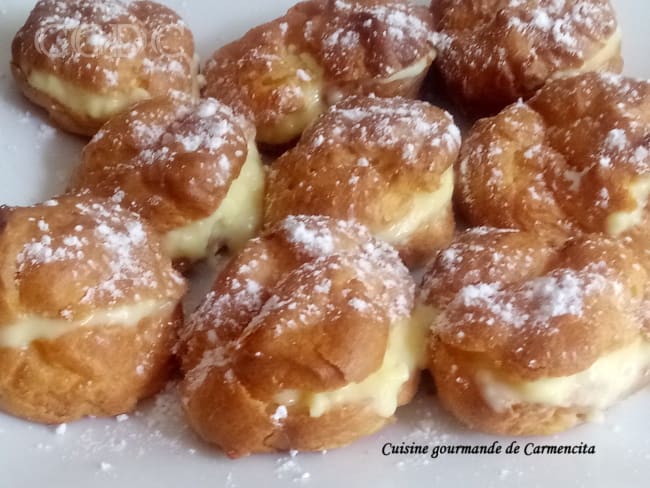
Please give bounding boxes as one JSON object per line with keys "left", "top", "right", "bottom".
{"left": 421, "top": 227, "right": 650, "bottom": 382}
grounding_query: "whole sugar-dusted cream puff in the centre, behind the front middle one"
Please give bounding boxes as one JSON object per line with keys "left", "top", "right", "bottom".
{"left": 265, "top": 96, "right": 460, "bottom": 266}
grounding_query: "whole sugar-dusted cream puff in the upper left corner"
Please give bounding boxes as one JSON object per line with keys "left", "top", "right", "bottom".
{"left": 11, "top": 0, "right": 198, "bottom": 136}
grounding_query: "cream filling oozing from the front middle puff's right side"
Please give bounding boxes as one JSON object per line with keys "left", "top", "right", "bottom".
{"left": 275, "top": 311, "right": 430, "bottom": 418}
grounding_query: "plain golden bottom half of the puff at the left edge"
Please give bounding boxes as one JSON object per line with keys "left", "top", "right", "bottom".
{"left": 0, "top": 306, "right": 183, "bottom": 424}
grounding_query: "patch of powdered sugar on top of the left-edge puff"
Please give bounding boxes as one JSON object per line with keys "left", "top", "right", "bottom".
{"left": 16, "top": 197, "right": 182, "bottom": 306}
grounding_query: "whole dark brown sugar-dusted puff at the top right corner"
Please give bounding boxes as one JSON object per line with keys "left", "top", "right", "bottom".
{"left": 431, "top": 0, "right": 623, "bottom": 115}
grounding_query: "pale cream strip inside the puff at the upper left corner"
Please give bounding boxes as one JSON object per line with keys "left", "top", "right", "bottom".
{"left": 27, "top": 71, "right": 151, "bottom": 119}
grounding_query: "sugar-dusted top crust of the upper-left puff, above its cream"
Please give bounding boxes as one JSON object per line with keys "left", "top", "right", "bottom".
{"left": 17, "top": 0, "right": 193, "bottom": 91}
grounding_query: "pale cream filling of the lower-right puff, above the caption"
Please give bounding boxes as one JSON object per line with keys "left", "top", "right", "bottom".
{"left": 476, "top": 340, "right": 650, "bottom": 412}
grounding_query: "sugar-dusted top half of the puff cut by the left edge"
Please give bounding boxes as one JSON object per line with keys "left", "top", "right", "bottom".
{"left": 0, "top": 196, "right": 185, "bottom": 332}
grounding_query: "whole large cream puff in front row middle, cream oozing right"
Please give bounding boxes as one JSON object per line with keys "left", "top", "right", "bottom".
{"left": 181, "top": 216, "right": 426, "bottom": 457}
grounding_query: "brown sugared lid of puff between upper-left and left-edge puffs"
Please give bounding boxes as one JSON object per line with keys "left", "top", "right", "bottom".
{"left": 72, "top": 96, "right": 255, "bottom": 234}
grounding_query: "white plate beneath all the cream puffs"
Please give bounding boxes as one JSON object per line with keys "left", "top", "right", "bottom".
{"left": 0, "top": 0, "right": 650, "bottom": 488}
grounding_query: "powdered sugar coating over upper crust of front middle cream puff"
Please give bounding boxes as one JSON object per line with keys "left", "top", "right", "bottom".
{"left": 182, "top": 216, "right": 414, "bottom": 390}
